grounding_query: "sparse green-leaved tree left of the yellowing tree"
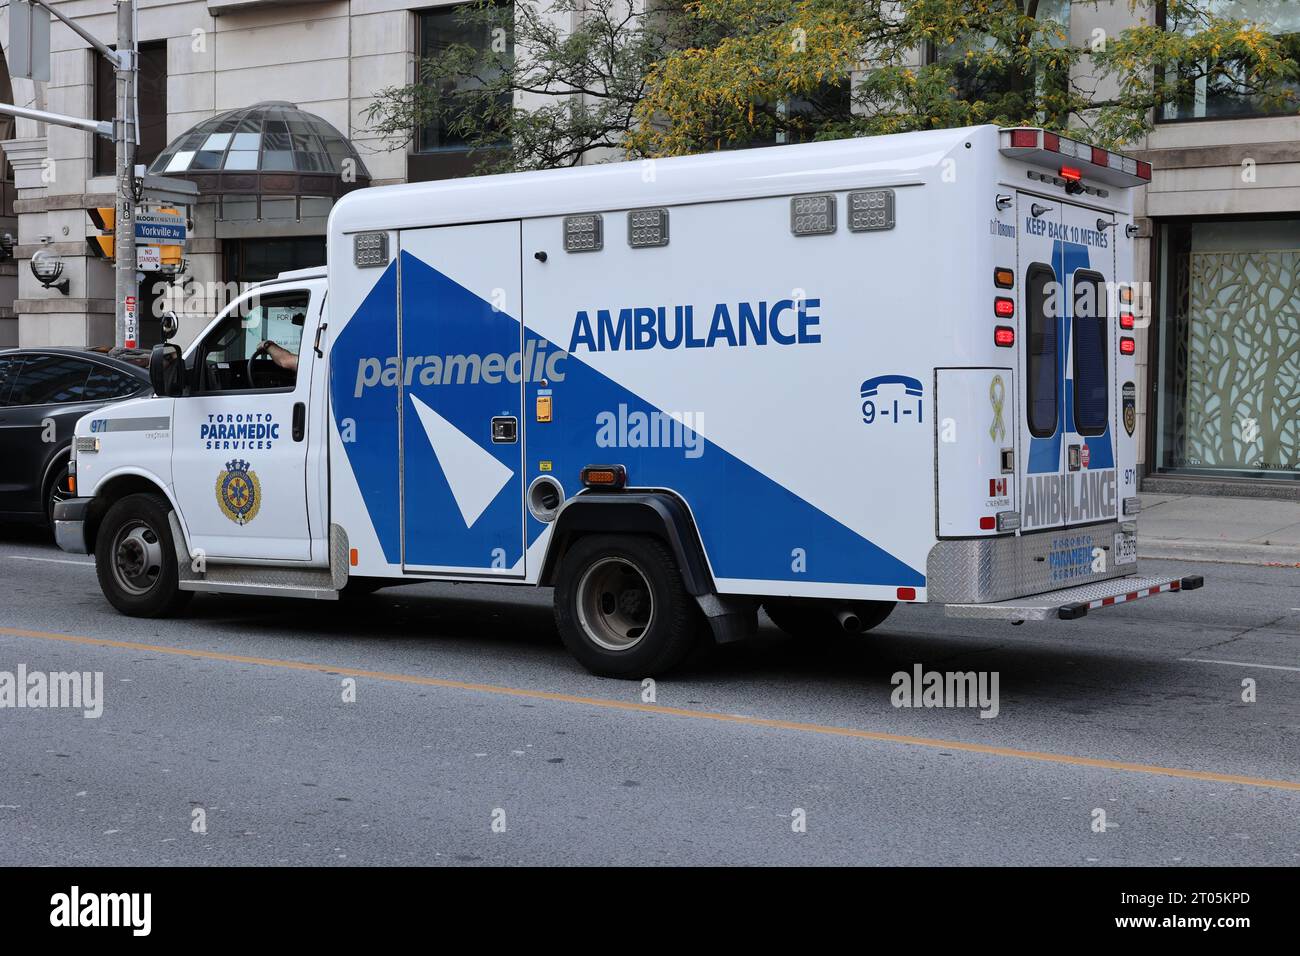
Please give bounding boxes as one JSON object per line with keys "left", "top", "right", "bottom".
{"left": 365, "top": 0, "right": 714, "bottom": 172}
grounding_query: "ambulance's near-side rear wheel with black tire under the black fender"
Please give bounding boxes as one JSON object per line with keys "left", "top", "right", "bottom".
{"left": 555, "top": 535, "right": 703, "bottom": 679}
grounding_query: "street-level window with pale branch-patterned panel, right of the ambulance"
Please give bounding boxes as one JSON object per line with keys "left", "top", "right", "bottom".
{"left": 1159, "top": 219, "right": 1300, "bottom": 481}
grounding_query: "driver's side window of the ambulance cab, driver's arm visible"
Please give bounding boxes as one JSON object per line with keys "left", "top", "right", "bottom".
{"left": 198, "top": 290, "right": 311, "bottom": 392}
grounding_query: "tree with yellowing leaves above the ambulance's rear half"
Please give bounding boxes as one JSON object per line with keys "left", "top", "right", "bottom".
{"left": 628, "top": 0, "right": 1300, "bottom": 155}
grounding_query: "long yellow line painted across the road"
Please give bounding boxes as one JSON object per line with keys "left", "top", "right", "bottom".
{"left": 0, "top": 627, "right": 1300, "bottom": 791}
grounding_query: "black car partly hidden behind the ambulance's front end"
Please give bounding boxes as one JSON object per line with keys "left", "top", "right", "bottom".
{"left": 0, "top": 349, "right": 153, "bottom": 522}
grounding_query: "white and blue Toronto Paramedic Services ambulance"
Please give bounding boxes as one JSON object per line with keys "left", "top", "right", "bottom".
{"left": 56, "top": 126, "right": 1201, "bottom": 678}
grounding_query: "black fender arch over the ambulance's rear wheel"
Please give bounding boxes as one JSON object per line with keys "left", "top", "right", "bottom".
{"left": 538, "top": 492, "right": 714, "bottom": 596}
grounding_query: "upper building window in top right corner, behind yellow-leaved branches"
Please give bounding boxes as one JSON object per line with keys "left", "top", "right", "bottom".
{"left": 1156, "top": 0, "right": 1300, "bottom": 122}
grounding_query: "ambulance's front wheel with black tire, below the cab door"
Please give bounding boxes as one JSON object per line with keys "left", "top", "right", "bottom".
{"left": 95, "top": 494, "right": 194, "bottom": 618}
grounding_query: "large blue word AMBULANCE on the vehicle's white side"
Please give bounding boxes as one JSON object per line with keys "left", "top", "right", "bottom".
{"left": 568, "top": 299, "right": 822, "bottom": 352}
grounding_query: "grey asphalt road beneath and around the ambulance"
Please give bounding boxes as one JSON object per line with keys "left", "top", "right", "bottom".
{"left": 0, "top": 529, "right": 1300, "bottom": 865}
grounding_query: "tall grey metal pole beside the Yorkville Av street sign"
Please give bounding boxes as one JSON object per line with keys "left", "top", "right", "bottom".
{"left": 113, "top": 0, "right": 139, "bottom": 349}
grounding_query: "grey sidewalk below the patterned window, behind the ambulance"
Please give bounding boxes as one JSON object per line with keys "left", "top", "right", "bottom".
{"left": 1138, "top": 493, "right": 1300, "bottom": 567}
